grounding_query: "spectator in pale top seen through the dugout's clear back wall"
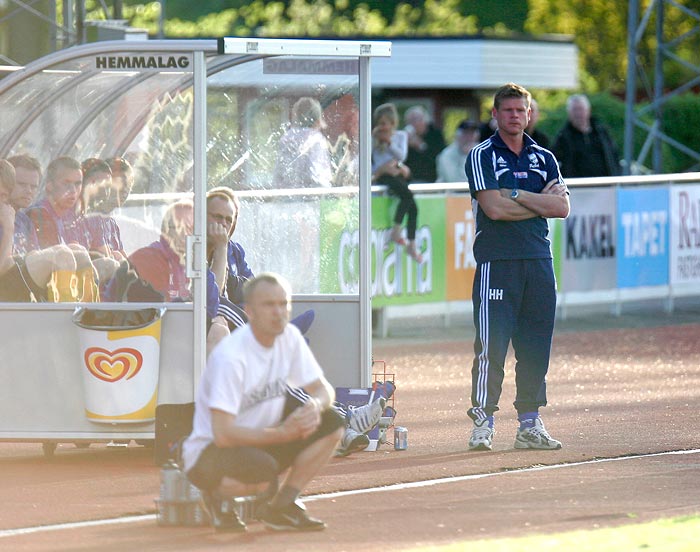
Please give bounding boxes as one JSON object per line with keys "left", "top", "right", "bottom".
{"left": 272, "top": 97, "right": 332, "bottom": 188}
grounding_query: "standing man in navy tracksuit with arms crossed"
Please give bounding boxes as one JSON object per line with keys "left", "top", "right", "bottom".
{"left": 465, "top": 83, "right": 569, "bottom": 450}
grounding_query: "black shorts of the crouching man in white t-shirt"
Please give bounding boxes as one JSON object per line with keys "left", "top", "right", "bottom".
{"left": 187, "top": 394, "right": 345, "bottom": 491}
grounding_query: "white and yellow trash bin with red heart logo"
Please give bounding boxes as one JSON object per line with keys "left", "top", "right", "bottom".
{"left": 73, "top": 307, "right": 165, "bottom": 424}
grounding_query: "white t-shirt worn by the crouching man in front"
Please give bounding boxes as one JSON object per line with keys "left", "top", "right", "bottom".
{"left": 183, "top": 324, "right": 323, "bottom": 471}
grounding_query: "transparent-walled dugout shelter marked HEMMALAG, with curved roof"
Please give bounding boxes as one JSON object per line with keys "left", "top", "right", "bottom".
{"left": 0, "top": 38, "right": 391, "bottom": 449}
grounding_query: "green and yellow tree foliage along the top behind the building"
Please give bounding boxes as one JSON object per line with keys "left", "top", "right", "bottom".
{"left": 86, "top": 0, "right": 700, "bottom": 170}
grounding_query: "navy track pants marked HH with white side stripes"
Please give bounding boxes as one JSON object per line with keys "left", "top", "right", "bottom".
{"left": 468, "top": 259, "right": 557, "bottom": 420}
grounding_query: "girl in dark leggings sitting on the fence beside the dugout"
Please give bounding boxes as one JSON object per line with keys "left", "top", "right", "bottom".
{"left": 372, "top": 103, "right": 423, "bottom": 263}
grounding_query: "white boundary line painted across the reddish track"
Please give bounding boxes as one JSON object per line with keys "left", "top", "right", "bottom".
{"left": 0, "top": 449, "right": 700, "bottom": 538}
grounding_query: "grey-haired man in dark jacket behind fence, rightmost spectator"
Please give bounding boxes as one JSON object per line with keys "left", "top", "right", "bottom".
{"left": 552, "top": 94, "right": 620, "bottom": 178}
